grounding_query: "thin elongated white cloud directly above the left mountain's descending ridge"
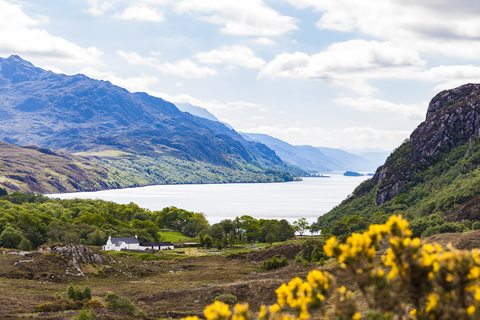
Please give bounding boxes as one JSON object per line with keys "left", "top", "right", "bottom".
{"left": 117, "top": 50, "right": 217, "bottom": 78}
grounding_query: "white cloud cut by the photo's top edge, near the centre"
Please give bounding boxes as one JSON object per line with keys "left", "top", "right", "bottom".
{"left": 176, "top": 0, "right": 298, "bottom": 37}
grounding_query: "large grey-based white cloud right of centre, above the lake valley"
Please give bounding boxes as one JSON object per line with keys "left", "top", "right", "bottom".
{"left": 259, "top": 40, "right": 425, "bottom": 95}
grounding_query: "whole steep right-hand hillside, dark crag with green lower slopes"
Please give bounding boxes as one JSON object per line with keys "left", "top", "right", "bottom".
{"left": 318, "top": 84, "right": 480, "bottom": 236}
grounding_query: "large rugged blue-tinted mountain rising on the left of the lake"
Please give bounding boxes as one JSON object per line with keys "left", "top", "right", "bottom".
{"left": 0, "top": 56, "right": 299, "bottom": 191}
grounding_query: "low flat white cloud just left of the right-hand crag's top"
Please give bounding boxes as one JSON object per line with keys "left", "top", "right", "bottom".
{"left": 334, "top": 97, "right": 428, "bottom": 120}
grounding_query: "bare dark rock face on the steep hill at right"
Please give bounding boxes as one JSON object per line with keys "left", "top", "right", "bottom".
{"left": 364, "top": 84, "right": 480, "bottom": 205}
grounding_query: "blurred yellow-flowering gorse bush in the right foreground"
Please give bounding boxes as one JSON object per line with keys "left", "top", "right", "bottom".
{"left": 185, "top": 216, "right": 480, "bottom": 320}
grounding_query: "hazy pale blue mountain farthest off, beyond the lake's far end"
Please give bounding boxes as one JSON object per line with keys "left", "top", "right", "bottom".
{"left": 241, "top": 132, "right": 376, "bottom": 172}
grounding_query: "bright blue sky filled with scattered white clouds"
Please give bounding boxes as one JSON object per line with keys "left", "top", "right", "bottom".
{"left": 0, "top": 0, "right": 480, "bottom": 150}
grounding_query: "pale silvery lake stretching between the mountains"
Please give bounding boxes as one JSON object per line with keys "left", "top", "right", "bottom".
{"left": 48, "top": 172, "right": 370, "bottom": 224}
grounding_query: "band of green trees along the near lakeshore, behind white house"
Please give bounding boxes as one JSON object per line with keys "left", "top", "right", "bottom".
{"left": 0, "top": 193, "right": 309, "bottom": 250}
